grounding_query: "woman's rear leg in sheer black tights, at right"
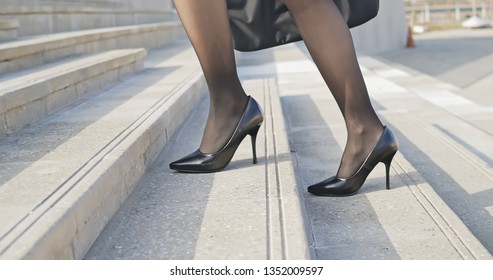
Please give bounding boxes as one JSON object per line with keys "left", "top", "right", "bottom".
{"left": 284, "top": 0, "right": 383, "bottom": 178}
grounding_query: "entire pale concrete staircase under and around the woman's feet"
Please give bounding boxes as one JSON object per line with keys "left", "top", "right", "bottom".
{"left": 0, "top": 2, "right": 493, "bottom": 259}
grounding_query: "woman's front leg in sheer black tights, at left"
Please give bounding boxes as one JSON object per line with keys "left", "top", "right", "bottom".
{"left": 174, "top": 0, "right": 248, "bottom": 153}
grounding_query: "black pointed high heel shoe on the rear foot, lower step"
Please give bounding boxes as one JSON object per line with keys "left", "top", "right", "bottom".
{"left": 308, "top": 126, "right": 399, "bottom": 196}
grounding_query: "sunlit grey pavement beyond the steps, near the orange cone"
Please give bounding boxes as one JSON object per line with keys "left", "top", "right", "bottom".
{"left": 378, "top": 28, "right": 493, "bottom": 109}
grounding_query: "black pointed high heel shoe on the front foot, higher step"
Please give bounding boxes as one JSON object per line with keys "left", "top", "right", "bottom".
{"left": 169, "top": 96, "right": 264, "bottom": 173}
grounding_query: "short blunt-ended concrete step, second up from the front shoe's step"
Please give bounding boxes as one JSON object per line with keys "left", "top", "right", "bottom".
{"left": 0, "top": 49, "right": 146, "bottom": 138}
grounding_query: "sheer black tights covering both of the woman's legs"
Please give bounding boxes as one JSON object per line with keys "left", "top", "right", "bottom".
{"left": 174, "top": 0, "right": 383, "bottom": 177}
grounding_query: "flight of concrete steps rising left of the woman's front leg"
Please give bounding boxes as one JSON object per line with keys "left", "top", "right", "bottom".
{"left": 0, "top": 3, "right": 204, "bottom": 259}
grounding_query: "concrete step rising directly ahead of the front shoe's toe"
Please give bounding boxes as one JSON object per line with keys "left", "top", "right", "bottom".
{"left": 0, "top": 40, "right": 204, "bottom": 259}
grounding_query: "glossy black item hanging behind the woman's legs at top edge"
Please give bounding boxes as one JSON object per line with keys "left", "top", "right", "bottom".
{"left": 227, "top": 0, "right": 379, "bottom": 52}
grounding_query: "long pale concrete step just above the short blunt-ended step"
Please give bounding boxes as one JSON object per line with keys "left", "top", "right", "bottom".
{"left": 0, "top": 21, "right": 182, "bottom": 74}
